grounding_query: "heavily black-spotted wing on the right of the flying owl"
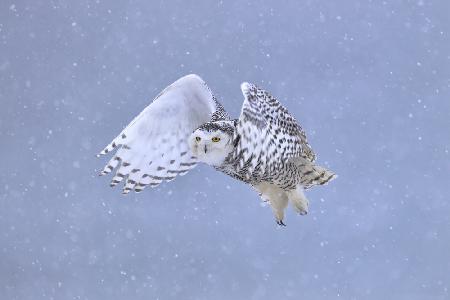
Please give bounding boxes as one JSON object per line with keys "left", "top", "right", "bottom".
{"left": 234, "top": 82, "right": 315, "bottom": 179}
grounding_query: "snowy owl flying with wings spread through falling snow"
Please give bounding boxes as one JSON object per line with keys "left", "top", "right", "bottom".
{"left": 99, "top": 74, "right": 336, "bottom": 225}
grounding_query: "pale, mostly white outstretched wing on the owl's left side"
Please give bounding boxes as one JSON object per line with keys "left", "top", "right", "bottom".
{"left": 98, "top": 74, "right": 227, "bottom": 194}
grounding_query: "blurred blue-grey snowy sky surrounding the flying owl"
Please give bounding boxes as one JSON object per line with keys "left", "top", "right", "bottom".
{"left": 0, "top": 0, "right": 450, "bottom": 299}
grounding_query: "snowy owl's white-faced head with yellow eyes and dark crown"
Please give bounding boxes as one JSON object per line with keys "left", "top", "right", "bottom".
{"left": 189, "top": 121, "right": 235, "bottom": 167}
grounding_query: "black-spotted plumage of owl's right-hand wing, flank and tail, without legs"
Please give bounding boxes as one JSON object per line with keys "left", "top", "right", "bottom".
{"left": 211, "top": 83, "right": 333, "bottom": 189}
